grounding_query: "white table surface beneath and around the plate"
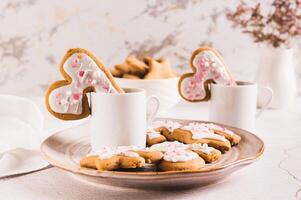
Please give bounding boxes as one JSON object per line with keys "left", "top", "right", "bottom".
{"left": 0, "top": 98, "right": 301, "bottom": 200}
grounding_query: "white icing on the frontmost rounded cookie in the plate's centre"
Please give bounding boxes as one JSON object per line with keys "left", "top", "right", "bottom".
{"left": 163, "top": 149, "right": 199, "bottom": 162}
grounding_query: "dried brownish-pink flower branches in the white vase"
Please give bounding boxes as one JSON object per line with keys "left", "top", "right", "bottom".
{"left": 227, "top": 0, "right": 301, "bottom": 48}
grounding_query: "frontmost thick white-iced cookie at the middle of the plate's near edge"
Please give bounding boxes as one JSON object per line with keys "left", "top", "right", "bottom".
{"left": 158, "top": 149, "right": 205, "bottom": 171}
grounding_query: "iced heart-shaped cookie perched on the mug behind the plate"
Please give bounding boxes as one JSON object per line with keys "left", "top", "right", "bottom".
{"left": 178, "top": 47, "right": 236, "bottom": 102}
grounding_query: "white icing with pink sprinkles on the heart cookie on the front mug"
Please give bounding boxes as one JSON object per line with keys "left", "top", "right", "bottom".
{"left": 49, "top": 53, "right": 117, "bottom": 115}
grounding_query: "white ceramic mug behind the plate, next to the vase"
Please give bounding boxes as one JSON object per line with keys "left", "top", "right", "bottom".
{"left": 209, "top": 81, "right": 273, "bottom": 131}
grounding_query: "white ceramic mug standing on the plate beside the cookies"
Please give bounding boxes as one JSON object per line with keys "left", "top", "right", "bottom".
{"left": 90, "top": 88, "right": 159, "bottom": 151}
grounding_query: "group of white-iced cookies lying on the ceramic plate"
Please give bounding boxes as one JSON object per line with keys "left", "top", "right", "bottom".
{"left": 80, "top": 120, "right": 241, "bottom": 171}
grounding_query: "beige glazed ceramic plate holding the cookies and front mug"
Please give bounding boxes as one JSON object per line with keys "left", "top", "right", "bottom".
{"left": 41, "top": 119, "right": 264, "bottom": 188}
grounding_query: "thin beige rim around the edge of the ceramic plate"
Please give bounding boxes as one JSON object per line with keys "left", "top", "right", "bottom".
{"left": 40, "top": 118, "right": 265, "bottom": 178}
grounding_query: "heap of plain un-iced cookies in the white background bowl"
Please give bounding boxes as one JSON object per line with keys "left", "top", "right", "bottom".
{"left": 111, "top": 56, "right": 177, "bottom": 79}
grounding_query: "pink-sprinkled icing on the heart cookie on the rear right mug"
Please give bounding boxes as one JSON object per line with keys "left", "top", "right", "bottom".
{"left": 180, "top": 50, "right": 235, "bottom": 101}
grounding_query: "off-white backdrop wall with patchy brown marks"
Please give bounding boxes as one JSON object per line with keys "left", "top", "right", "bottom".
{"left": 0, "top": 0, "right": 301, "bottom": 95}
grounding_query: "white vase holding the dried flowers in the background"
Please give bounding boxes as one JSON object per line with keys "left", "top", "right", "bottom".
{"left": 256, "top": 48, "right": 296, "bottom": 109}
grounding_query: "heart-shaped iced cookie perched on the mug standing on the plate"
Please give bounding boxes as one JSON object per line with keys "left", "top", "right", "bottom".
{"left": 45, "top": 48, "right": 123, "bottom": 120}
